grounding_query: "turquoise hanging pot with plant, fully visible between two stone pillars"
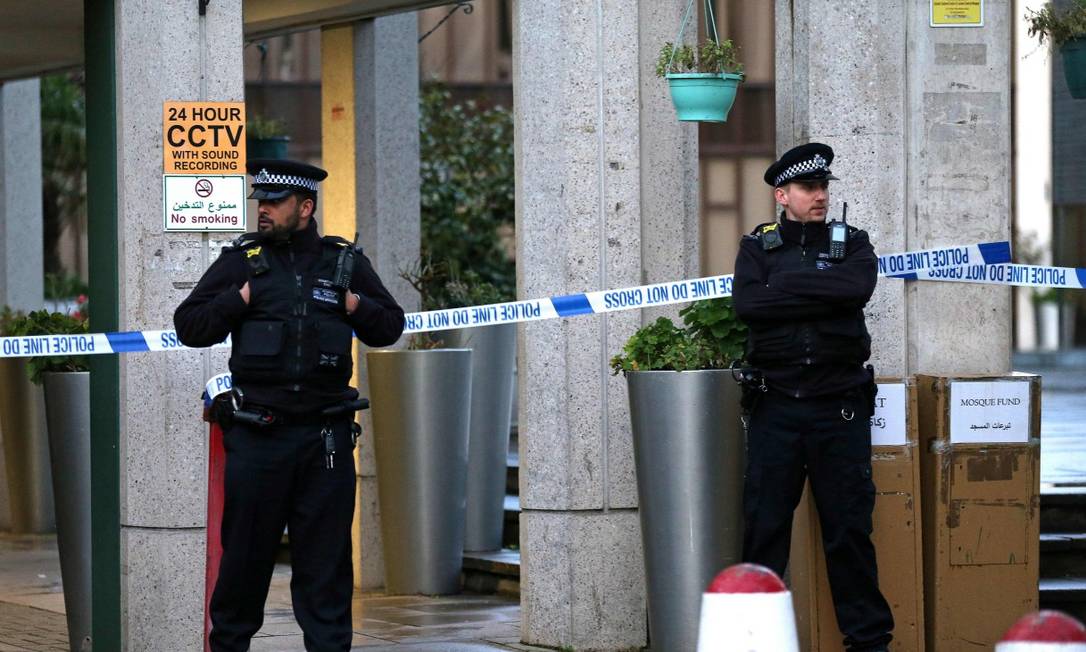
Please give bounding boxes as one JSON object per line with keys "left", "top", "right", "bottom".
{"left": 656, "top": 0, "right": 743, "bottom": 123}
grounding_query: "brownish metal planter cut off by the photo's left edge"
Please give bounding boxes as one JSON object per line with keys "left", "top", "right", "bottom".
{"left": 0, "top": 358, "right": 56, "bottom": 534}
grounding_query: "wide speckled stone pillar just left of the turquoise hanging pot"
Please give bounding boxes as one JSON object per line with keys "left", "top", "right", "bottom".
{"left": 514, "top": 0, "right": 698, "bottom": 650}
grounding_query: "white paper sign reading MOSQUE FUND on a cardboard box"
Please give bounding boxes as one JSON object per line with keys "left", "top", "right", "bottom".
{"left": 950, "top": 380, "right": 1031, "bottom": 443}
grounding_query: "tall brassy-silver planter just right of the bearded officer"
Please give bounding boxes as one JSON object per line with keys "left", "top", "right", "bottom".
{"left": 366, "top": 349, "right": 471, "bottom": 595}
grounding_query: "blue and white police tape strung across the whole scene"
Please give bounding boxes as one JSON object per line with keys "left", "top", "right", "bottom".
{"left": 0, "top": 241, "right": 1072, "bottom": 358}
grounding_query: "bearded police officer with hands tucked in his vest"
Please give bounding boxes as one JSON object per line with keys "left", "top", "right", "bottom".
{"left": 174, "top": 160, "right": 404, "bottom": 652}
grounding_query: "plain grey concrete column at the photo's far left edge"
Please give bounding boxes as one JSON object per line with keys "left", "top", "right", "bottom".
{"left": 0, "top": 78, "right": 43, "bottom": 311}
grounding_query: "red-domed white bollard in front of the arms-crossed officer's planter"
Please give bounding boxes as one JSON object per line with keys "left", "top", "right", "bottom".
{"left": 697, "top": 564, "right": 799, "bottom": 652}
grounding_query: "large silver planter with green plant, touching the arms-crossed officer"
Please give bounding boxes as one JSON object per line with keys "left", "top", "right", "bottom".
{"left": 627, "top": 369, "right": 746, "bottom": 652}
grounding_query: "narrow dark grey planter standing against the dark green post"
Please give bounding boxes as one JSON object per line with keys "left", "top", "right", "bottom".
{"left": 45, "top": 372, "right": 90, "bottom": 651}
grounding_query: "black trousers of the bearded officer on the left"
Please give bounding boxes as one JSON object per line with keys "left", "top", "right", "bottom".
{"left": 210, "top": 417, "right": 355, "bottom": 652}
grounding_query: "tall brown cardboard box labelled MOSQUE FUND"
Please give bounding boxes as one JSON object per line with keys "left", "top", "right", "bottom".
{"left": 917, "top": 374, "right": 1040, "bottom": 652}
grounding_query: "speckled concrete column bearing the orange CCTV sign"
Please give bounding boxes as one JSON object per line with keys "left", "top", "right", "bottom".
{"left": 116, "top": 0, "right": 244, "bottom": 650}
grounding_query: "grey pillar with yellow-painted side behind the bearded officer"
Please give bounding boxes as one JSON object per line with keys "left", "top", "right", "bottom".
{"left": 321, "top": 13, "right": 419, "bottom": 590}
